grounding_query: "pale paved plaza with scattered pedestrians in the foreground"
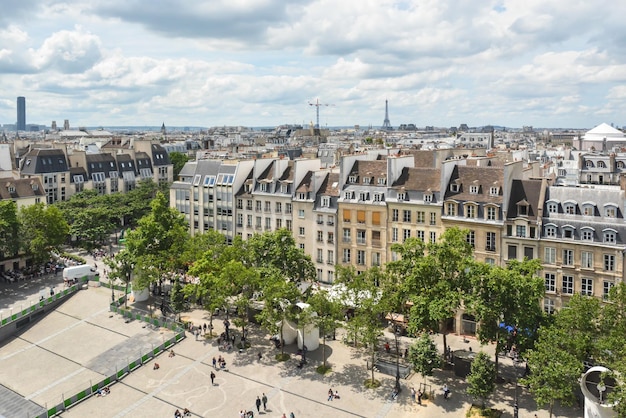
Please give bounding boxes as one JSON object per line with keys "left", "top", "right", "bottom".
{"left": 0, "top": 266, "right": 582, "bottom": 418}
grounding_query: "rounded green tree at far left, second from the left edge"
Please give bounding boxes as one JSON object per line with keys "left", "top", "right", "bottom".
{"left": 19, "top": 203, "right": 70, "bottom": 264}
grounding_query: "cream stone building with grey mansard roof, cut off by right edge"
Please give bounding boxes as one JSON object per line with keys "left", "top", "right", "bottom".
{"left": 539, "top": 186, "right": 626, "bottom": 312}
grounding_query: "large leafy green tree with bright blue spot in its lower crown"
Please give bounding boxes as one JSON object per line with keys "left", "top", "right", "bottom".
{"left": 465, "top": 260, "right": 545, "bottom": 376}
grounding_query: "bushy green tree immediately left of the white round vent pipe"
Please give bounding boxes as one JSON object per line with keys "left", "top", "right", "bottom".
{"left": 522, "top": 325, "right": 583, "bottom": 418}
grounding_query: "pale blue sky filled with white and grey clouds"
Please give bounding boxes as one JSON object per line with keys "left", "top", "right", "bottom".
{"left": 0, "top": 0, "right": 626, "bottom": 128}
